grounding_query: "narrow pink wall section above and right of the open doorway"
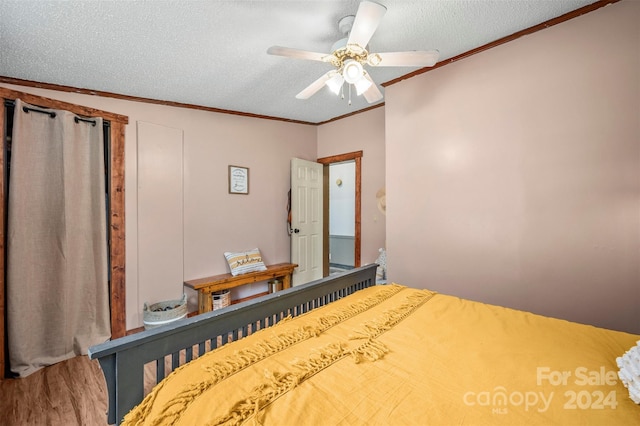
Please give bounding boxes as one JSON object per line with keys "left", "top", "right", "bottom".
{"left": 318, "top": 106, "right": 386, "bottom": 265}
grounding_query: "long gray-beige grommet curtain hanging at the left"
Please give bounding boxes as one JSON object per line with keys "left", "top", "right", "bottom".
{"left": 7, "top": 100, "right": 111, "bottom": 377}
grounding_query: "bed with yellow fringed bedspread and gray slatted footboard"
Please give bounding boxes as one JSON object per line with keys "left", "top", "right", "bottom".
{"left": 89, "top": 265, "right": 640, "bottom": 425}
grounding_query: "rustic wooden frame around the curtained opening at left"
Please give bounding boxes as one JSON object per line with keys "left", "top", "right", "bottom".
{"left": 0, "top": 87, "right": 129, "bottom": 380}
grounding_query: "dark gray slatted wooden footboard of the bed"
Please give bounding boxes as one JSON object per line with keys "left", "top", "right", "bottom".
{"left": 89, "top": 264, "right": 377, "bottom": 424}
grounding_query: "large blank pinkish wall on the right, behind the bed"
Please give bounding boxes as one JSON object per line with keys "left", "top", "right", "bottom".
{"left": 386, "top": 1, "right": 640, "bottom": 333}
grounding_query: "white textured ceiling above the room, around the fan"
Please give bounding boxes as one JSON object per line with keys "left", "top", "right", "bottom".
{"left": 0, "top": 0, "right": 594, "bottom": 123}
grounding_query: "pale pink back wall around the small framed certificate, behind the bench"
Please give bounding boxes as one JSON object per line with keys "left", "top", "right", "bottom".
{"left": 2, "top": 84, "right": 317, "bottom": 329}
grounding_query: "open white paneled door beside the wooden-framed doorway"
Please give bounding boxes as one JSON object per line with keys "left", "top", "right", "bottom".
{"left": 291, "top": 158, "right": 323, "bottom": 286}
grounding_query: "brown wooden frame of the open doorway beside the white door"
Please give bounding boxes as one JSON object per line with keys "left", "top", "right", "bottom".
{"left": 316, "top": 151, "right": 362, "bottom": 276}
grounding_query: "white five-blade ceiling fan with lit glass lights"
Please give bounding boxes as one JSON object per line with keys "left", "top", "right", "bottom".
{"left": 267, "top": 0, "right": 439, "bottom": 105}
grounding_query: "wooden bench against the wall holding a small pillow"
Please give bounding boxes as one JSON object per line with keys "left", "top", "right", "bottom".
{"left": 184, "top": 263, "right": 298, "bottom": 314}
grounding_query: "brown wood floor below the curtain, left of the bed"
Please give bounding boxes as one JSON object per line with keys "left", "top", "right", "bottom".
{"left": 0, "top": 356, "right": 107, "bottom": 426}
